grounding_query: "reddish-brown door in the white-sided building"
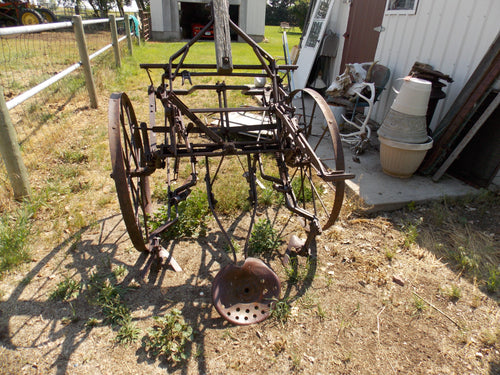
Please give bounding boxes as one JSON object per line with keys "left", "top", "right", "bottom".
{"left": 340, "top": 0, "right": 386, "bottom": 72}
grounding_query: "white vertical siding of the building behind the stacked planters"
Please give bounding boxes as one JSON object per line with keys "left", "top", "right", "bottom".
{"left": 372, "top": 0, "right": 500, "bottom": 129}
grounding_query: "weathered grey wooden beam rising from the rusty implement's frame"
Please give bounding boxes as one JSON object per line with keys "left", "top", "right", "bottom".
{"left": 213, "top": 0, "right": 233, "bottom": 74}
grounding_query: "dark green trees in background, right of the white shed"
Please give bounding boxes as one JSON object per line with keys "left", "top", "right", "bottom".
{"left": 266, "top": 0, "right": 310, "bottom": 29}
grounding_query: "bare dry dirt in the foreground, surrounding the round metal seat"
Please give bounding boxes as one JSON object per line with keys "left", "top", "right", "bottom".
{"left": 0, "top": 192, "right": 500, "bottom": 374}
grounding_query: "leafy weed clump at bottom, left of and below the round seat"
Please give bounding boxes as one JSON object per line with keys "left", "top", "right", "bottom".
{"left": 142, "top": 309, "right": 193, "bottom": 362}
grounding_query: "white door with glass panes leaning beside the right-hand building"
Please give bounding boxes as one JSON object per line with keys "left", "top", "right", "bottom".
{"left": 293, "top": 0, "right": 335, "bottom": 89}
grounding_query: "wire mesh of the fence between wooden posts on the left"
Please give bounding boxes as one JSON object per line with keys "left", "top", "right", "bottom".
{"left": 0, "top": 19, "right": 132, "bottom": 203}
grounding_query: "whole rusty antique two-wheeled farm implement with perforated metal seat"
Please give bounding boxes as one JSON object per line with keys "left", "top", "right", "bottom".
{"left": 109, "top": 0, "right": 353, "bottom": 324}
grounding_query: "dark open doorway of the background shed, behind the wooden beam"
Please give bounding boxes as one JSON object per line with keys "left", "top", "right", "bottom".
{"left": 179, "top": 2, "right": 240, "bottom": 40}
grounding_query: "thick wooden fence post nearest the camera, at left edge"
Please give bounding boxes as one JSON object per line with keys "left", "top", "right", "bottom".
{"left": 0, "top": 86, "right": 31, "bottom": 200}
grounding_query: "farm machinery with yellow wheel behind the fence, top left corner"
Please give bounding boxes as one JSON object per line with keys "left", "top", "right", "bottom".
{"left": 0, "top": 0, "right": 57, "bottom": 26}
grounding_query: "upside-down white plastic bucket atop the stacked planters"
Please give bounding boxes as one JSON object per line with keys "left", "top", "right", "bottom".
{"left": 391, "top": 78, "right": 432, "bottom": 116}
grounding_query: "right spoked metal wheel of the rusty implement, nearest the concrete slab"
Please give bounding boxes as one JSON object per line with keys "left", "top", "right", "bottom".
{"left": 288, "top": 89, "right": 345, "bottom": 230}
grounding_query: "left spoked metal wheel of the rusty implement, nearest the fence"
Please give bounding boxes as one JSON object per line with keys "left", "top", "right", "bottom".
{"left": 108, "top": 93, "right": 151, "bottom": 251}
